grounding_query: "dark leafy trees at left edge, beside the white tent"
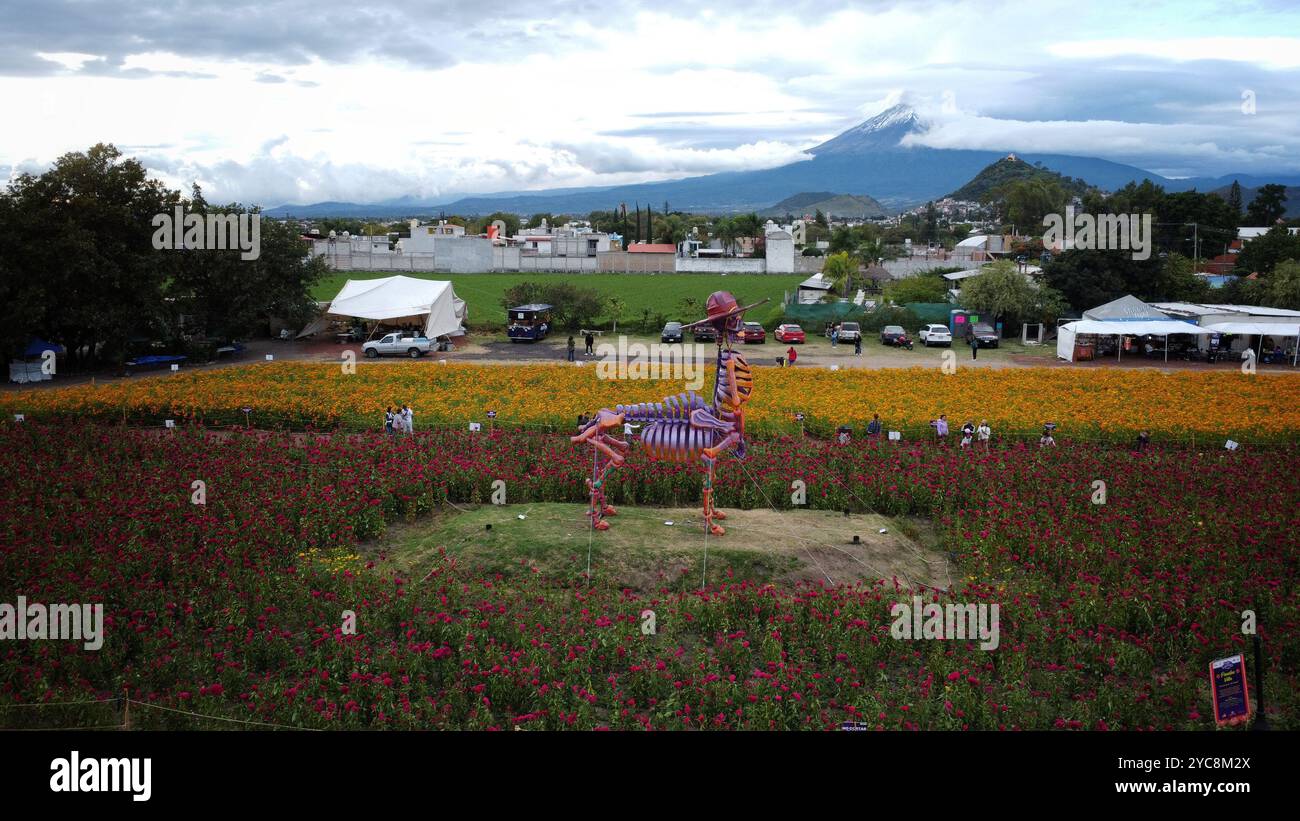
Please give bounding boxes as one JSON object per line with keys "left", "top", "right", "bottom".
{"left": 0, "top": 144, "right": 328, "bottom": 370}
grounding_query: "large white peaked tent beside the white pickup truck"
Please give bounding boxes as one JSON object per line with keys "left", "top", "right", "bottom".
{"left": 298, "top": 277, "right": 465, "bottom": 339}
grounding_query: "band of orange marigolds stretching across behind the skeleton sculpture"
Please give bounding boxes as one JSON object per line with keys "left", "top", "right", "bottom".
{"left": 0, "top": 362, "right": 1300, "bottom": 442}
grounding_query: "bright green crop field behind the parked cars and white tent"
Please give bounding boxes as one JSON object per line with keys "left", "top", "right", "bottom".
{"left": 312, "top": 272, "right": 806, "bottom": 326}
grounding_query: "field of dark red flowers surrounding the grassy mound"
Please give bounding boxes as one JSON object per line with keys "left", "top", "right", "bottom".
{"left": 0, "top": 422, "right": 1300, "bottom": 730}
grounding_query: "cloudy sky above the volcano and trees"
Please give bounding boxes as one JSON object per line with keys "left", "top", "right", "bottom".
{"left": 0, "top": 0, "right": 1300, "bottom": 207}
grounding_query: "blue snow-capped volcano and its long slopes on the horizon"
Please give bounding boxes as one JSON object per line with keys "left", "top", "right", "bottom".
{"left": 265, "top": 104, "right": 1300, "bottom": 218}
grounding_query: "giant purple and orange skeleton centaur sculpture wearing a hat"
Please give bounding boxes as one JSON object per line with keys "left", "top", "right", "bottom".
{"left": 571, "top": 291, "right": 767, "bottom": 537}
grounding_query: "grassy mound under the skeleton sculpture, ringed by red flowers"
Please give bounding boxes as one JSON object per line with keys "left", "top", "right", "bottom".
{"left": 368, "top": 503, "right": 950, "bottom": 591}
